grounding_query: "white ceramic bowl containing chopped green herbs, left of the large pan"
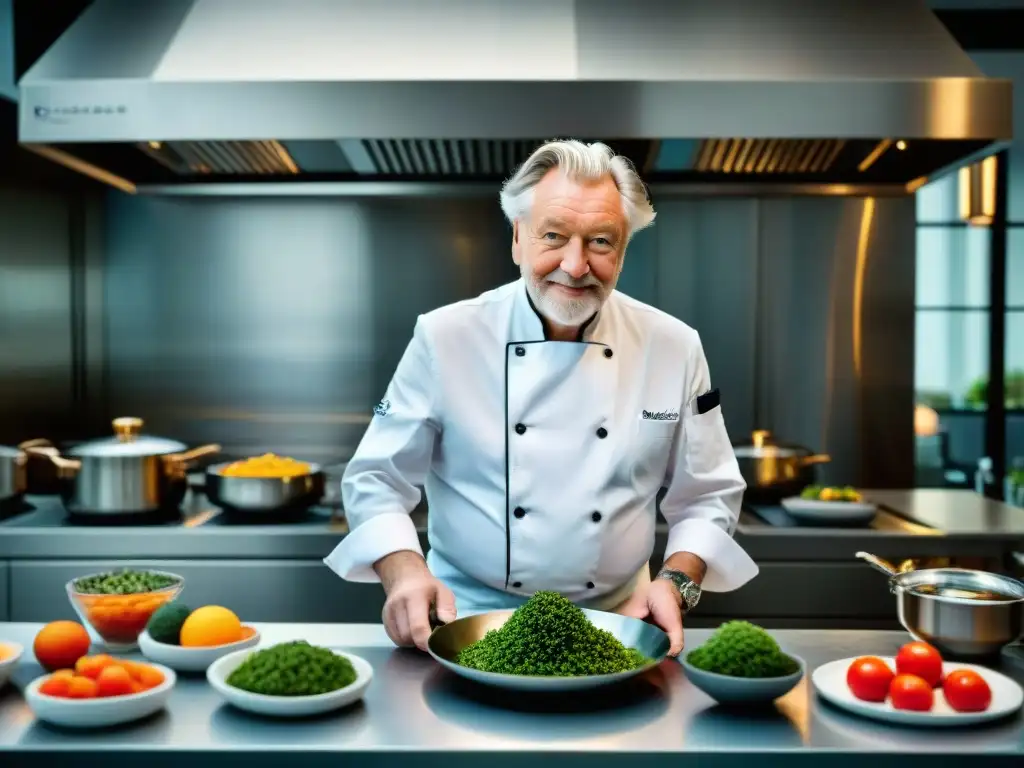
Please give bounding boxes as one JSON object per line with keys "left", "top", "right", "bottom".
{"left": 206, "top": 648, "right": 374, "bottom": 717}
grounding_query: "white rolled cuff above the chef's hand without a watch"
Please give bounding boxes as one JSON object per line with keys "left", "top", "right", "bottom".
{"left": 324, "top": 512, "right": 423, "bottom": 583}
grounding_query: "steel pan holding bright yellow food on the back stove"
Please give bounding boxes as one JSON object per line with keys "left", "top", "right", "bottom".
{"left": 206, "top": 462, "right": 325, "bottom": 515}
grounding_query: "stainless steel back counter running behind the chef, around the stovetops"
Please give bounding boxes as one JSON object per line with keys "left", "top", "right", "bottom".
{"left": 0, "top": 489, "right": 1024, "bottom": 562}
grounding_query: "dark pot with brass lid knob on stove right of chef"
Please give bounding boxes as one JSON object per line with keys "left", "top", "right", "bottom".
{"left": 733, "top": 429, "right": 831, "bottom": 503}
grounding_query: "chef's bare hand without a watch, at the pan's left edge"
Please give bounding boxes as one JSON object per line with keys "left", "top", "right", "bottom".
{"left": 375, "top": 551, "right": 456, "bottom": 650}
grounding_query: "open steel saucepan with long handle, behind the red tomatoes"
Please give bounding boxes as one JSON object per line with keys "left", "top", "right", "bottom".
{"left": 857, "top": 552, "right": 1024, "bottom": 658}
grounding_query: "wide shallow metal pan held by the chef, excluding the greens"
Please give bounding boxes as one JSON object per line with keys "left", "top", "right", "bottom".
{"left": 427, "top": 608, "right": 672, "bottom": 693}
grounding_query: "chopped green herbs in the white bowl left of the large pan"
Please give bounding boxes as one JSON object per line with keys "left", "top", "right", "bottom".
{"left": 227, "top": 640, "right": 356, "bottom": 696}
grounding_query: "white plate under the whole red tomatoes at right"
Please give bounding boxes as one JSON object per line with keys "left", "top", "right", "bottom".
{"left": 811, "top": 656, "right": 1024, "bottom": 726}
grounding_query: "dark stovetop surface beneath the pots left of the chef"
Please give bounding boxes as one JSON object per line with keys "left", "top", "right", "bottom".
{"left": 0, "top": 492, "right": 344, "bottom": 528}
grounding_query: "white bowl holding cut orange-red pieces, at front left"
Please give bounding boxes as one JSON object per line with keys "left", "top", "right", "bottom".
{"left": 25, "top": 664, "right": 177, "bottom": 728}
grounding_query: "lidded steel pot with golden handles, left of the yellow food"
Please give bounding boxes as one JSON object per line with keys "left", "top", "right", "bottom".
{"left": 28, "top": 417, "right": 220, "bottom": 515}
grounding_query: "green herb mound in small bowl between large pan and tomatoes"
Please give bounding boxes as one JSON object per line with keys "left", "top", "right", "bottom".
{"left": 686, "top": 622, "right": 800, "bottom": 678}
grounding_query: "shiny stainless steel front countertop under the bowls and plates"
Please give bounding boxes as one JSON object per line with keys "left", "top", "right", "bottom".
{"left": 0, "top": 624, "right": 1024, "bottom": 768}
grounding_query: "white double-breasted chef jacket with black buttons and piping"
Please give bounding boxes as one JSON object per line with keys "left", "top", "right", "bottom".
{"left": 325, "top": 280, "right": 758, "bottom": 614}
